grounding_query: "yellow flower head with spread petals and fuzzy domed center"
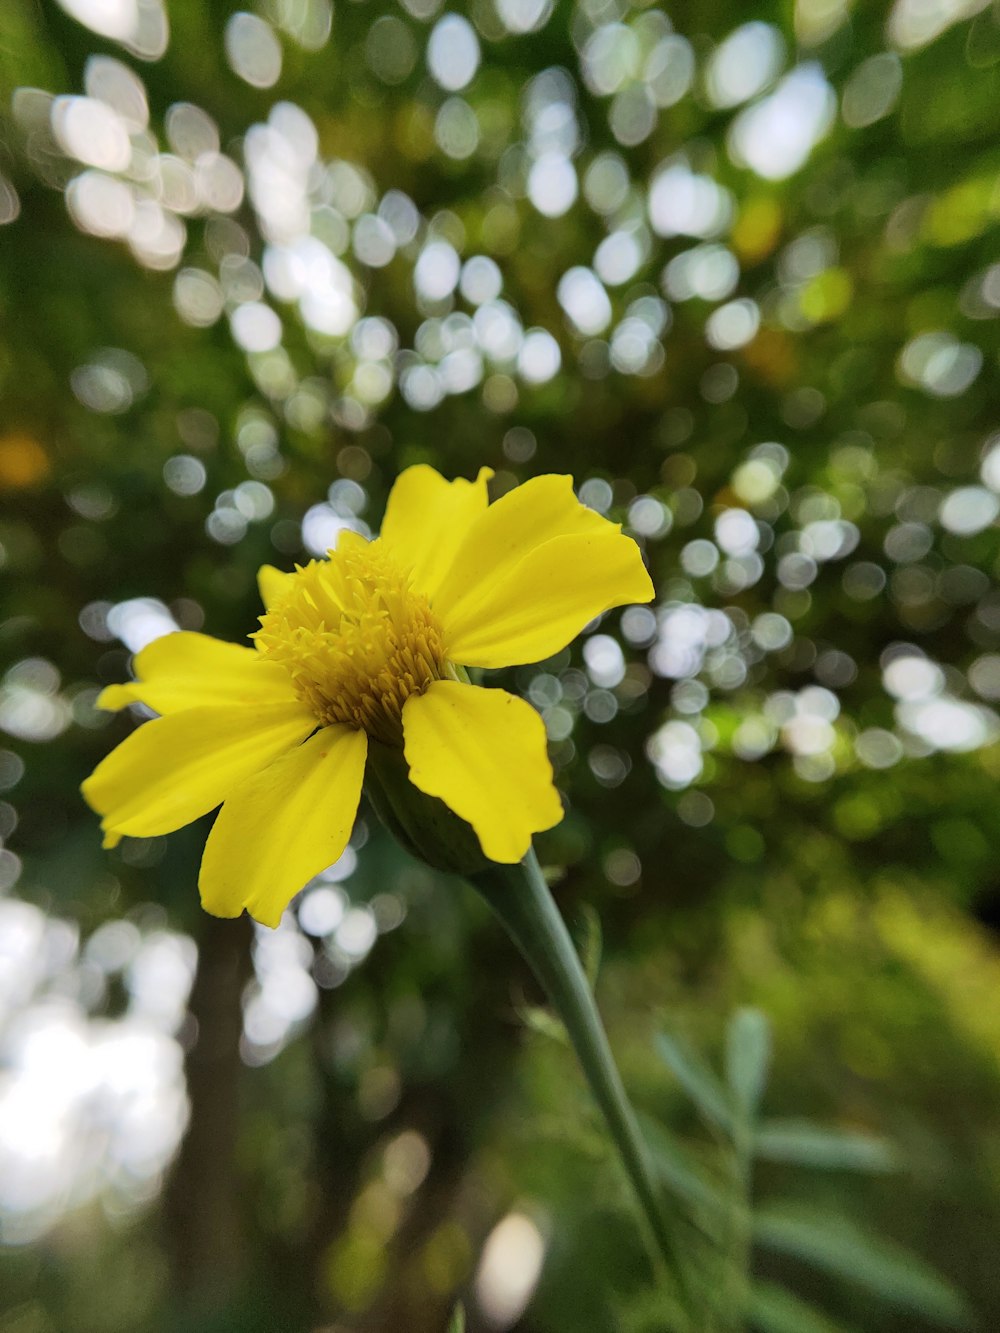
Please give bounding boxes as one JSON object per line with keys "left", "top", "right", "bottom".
{"left": 83, "top": 465, "right": 653, "bottom": 925}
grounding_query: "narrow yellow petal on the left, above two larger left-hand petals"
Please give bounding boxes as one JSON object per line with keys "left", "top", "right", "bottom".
{"left": 97, "top": 632, "right": 296, "bottom": 713}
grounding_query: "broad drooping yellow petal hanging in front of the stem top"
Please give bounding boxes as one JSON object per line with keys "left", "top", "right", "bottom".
{"left": 403, "top": 680, "right": 563, "bottom": 864}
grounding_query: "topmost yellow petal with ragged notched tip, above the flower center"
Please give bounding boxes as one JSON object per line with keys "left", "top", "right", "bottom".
{"left": 381, "top": 463, "right": 493, "bottom": 597}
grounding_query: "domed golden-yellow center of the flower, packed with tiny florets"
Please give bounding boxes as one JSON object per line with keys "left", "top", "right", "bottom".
{"left": 252, "top": 533, "right": 449, "bottom": 745}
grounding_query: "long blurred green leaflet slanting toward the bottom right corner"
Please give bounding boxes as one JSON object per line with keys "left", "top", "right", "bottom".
{"left": 753, "top": 1204, "right": 968, "bottom": 1328}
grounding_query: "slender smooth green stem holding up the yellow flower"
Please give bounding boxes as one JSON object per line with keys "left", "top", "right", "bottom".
{"left": 469, "top": 849, "right": 679, "bottom": 1276}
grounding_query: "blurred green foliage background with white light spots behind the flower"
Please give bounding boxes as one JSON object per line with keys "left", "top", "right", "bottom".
{"left": 0, "top": 0, "right": 1000, "bottom": 1333}
